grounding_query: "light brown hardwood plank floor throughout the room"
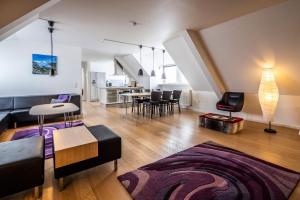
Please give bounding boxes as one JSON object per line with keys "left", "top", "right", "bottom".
{"left": 0, "top": 103, "right": 300, "bottom": 200}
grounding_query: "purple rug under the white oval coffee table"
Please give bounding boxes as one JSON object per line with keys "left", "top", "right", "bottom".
{"left": 11, "top": 121, "right": 83, "bottom": 159}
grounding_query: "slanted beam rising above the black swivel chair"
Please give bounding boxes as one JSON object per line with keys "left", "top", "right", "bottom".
{"left": 182, "top": 30, "right": 226, "bottom": 98}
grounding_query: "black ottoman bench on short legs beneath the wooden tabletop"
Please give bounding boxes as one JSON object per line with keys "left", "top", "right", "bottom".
{"left": 54, "top": 125, "right": 121, "bottom": 188}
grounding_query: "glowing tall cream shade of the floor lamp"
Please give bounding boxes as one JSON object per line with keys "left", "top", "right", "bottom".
{"left": 258, "top": 69, "right": 279, "bottom": 122}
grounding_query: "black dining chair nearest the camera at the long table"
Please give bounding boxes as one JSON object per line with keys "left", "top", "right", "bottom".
{"left": 143, "top": 91, "right": 162, "bottom": 118}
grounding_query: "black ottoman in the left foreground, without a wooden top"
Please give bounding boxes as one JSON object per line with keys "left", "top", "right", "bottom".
{"left": 0, "top": 136, "right": 45, "bottom": 197}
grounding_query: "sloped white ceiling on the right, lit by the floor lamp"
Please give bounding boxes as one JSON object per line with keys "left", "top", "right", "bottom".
{"left": 199, "top": 0, "right": 300, "bottom": 95}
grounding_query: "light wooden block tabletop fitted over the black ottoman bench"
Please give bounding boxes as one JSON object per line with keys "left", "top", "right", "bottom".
{"left": 53, "top": 126, "right": 98, "bottom": 189}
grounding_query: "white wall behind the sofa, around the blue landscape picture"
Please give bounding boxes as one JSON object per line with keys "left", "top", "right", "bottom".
{"left": 0, "top": 37, "right": 81, "bottom": 96}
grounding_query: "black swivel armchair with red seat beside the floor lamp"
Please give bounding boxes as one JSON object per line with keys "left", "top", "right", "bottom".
{"left": 216, "top": 92, "right": 244, "bottom": 118}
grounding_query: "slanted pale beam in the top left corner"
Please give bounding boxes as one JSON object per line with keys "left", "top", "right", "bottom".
{"left": 0, "top": 0, "right": 61, "bottom": 41}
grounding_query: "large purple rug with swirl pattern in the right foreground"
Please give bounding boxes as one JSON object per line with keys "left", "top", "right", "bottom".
{"left": 118, "top": 142, "right": 300, "bottom": 200}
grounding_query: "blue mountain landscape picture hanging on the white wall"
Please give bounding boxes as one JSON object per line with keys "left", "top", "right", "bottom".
{"left": 32, "top": 54, "right": 57, "bottom": 75}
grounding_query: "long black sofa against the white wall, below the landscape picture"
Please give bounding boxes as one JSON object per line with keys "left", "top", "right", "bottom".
{"left": 0, "top": 94, "right": 81, "bottom": 133}
